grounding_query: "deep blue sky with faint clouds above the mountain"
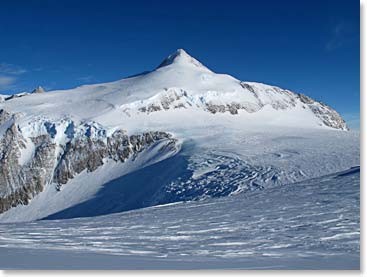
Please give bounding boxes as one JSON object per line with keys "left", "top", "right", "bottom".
{"left": 0, "top": 0, "right": 360, "bottom": 127}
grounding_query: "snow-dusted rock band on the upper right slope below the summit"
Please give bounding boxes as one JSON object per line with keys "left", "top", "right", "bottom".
{"left": 123, "top": 82, "right": 348, "bottom": 130}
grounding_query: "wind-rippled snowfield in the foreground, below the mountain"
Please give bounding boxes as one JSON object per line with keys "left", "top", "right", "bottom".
{"left": 0, "top": 167, "right": 360, "bottom": 269}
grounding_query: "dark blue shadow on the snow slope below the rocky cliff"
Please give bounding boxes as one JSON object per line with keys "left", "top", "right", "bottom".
{"left": 43, "top": 153, "right": 192, "bottom": 219}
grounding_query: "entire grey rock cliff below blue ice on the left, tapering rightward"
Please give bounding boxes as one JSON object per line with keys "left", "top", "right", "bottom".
{"left": 0, "top": 110, "right": 176, "bottom": 213}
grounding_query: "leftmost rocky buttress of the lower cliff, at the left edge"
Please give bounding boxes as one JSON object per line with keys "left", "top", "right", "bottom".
{"left": 0, "top": 123, "right": 55, "bottom": 212}
